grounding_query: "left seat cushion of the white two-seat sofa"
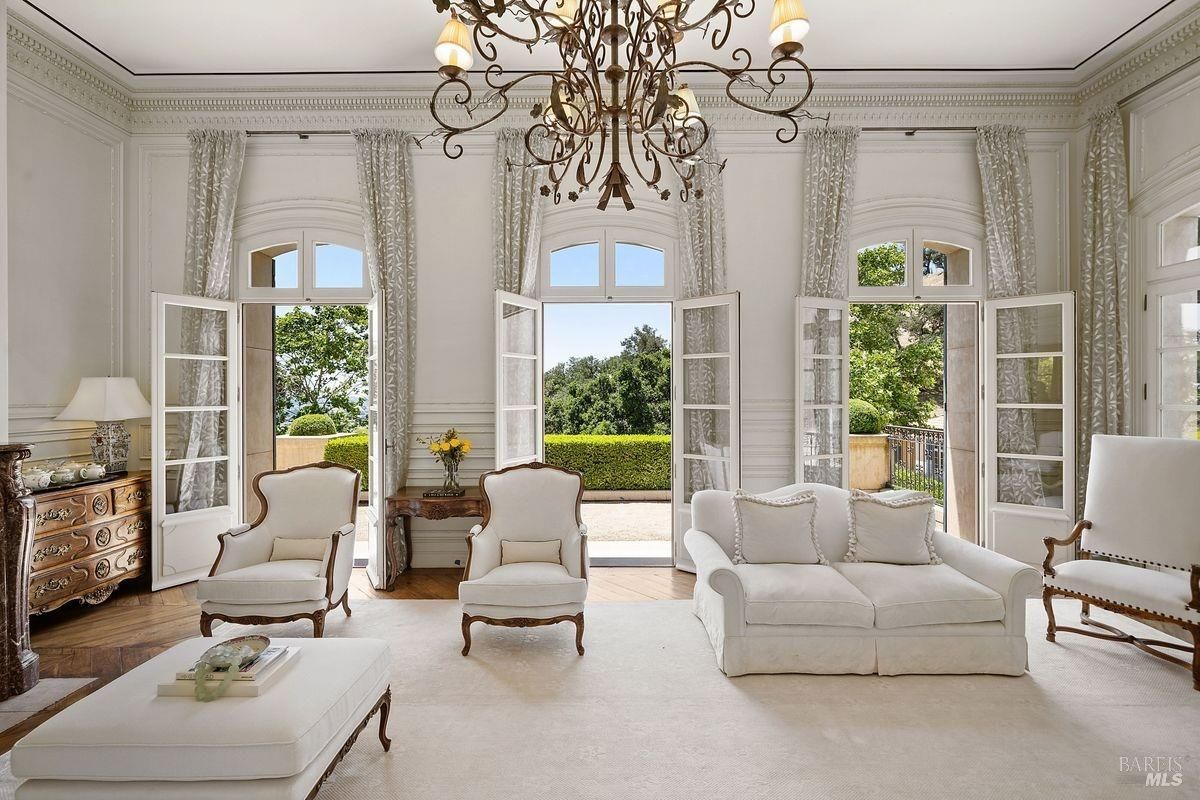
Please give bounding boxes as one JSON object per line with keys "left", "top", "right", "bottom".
{"left": 733, "top": 564, "right": 875, "bottom": 627}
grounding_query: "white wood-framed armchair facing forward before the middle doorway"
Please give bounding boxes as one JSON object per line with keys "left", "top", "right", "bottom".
{"left": 458, "top": 462, "right": 588, "bottom": 656}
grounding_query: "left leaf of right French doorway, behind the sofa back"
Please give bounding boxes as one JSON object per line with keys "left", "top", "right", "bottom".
{"left": 796, "top": 297, "right": 850, "bottom": 487}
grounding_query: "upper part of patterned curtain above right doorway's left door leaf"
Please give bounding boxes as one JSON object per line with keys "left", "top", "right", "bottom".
{"left": 800, "top": 126, "right": 859, "bottom": 300}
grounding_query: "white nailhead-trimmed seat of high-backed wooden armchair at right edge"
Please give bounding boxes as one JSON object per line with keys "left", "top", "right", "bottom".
{"left": 1044, "top": 559, "right": 1200, "bottom": 622}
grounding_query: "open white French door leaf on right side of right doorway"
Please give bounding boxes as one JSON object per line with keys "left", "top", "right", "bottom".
{"left": 984, "top": 291, "right": 1075, "bottom": 565}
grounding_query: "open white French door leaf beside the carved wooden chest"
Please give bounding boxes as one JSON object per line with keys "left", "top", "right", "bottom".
{"left": 150, "top": 293, "right": 241, "bottom": 590}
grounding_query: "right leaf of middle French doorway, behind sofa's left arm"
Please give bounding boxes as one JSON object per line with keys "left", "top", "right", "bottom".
{"left": 671, "top": 291, "right": 742, "bottom": 572}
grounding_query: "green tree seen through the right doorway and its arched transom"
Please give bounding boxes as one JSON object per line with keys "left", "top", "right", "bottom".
{"left": 850, "top": 243, "right": 946, "bottom": 426}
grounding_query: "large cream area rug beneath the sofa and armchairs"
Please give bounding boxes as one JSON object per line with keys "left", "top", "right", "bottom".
{"left": 0, "top": 600, "right": 1200, "bottom": 800}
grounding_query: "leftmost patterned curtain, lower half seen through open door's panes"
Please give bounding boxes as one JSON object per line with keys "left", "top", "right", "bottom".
{"left": 174, "top": 130, "right": 246, "bottom": 511}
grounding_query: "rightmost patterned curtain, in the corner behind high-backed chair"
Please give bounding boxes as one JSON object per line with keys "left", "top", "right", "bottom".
{"left": 1076, "top": 106, "right": 1133, "bottom": 509}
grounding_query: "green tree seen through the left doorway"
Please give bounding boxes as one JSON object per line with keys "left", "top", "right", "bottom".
{"left": 275, "top": 306, "right": 367, "bottom": 433}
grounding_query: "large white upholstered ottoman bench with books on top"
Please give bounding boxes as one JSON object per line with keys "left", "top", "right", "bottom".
{"left": 11, "top": 638, "right": 391, "bottom": 800}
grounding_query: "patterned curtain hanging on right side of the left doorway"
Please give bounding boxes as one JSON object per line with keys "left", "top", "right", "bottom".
{"left": 354, "top": 130, "right": 416, "bottom": 568}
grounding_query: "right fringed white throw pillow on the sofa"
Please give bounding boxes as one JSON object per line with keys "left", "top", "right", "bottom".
{"left": 846, "top": 489, "right": 942, "bottom": 564}
